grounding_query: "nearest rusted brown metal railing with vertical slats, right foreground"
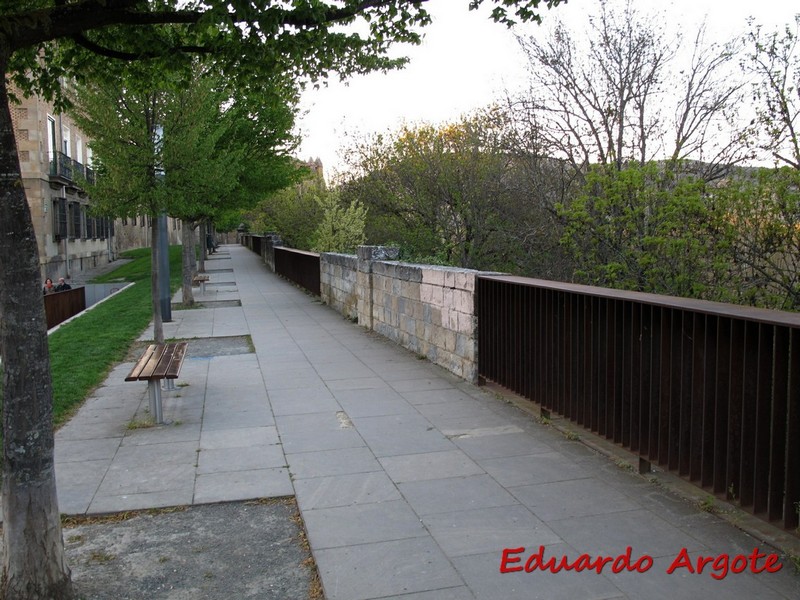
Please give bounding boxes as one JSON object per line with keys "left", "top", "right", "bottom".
{"left": 476, "top": 276, "right": 800, "bottom": 531}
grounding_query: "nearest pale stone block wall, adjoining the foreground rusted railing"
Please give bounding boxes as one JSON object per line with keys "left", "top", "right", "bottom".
{"left": 320, "top": 246, "right": 479, "bottom": 382}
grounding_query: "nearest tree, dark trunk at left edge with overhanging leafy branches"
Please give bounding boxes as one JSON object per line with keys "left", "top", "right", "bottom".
{"left": 0, "top": 0, "right": 558, "bottom": 599}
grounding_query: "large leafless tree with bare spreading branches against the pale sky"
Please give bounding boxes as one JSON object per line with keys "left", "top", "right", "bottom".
{"left": 516, "top": 0, "right": 747, "bottom": 179}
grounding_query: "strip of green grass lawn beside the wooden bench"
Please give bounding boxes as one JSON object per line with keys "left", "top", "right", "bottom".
{"left": 49, "top": 246, "right": 181, "bottom": 426}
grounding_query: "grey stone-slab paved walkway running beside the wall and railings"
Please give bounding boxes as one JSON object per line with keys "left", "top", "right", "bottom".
{"left": 56, "top": 246, "right": 800, "bottom": 600}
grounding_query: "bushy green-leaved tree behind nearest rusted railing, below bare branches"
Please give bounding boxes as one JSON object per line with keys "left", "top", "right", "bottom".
{"left": 560, "top": 162, "right": 735, "bottom": 300}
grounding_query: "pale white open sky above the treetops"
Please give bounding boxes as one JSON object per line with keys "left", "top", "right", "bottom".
{"left": 297, "top": 0, "right": 800, "bottom": 180}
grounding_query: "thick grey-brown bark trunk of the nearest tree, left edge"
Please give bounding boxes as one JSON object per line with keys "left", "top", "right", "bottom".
{"left": 0, "top": 63, "right": 74, "bottom": 600}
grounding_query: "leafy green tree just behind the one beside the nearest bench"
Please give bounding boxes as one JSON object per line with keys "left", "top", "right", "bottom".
{"left": 163, "top": 66, "right": 298, "bottom": 304}
